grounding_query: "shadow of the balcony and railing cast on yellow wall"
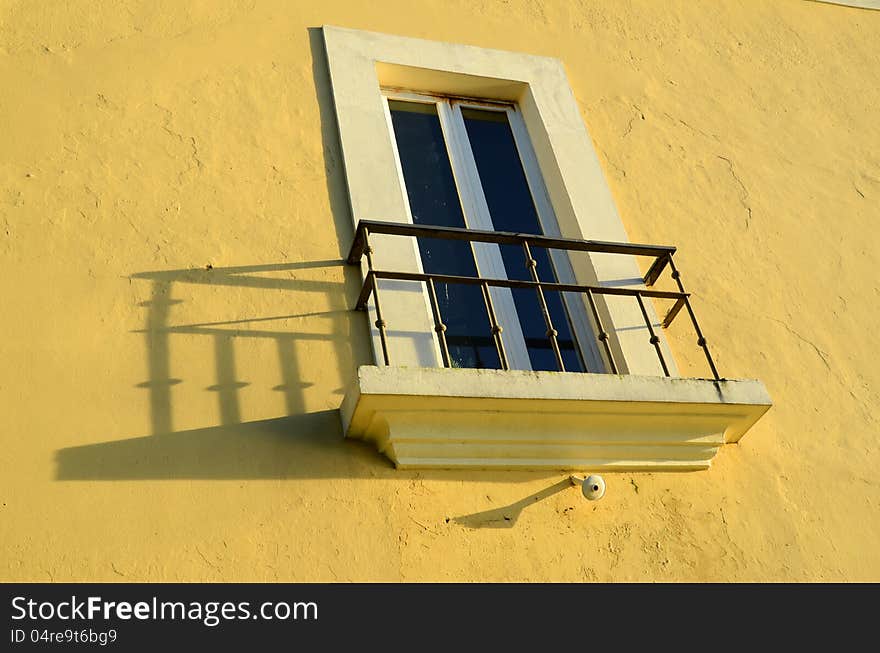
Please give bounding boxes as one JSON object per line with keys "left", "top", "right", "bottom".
{"left": 56, "top": 260, "right": 391, "bottom": 480}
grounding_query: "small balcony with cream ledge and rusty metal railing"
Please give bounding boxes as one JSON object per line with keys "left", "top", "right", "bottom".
{"left": 341, "top": 221, "right": 771, "bottom": 471}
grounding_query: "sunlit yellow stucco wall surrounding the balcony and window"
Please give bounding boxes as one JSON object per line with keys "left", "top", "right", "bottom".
{"left": 0, "top": 0, "right": 880, "bottom": 581}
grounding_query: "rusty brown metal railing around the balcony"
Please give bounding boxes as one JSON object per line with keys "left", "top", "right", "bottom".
{"left": 348, "top": 220, "right": 722, "bottom": 381}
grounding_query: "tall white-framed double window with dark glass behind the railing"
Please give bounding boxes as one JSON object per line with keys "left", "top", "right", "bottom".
{"left": 385, "top": 91, "right": 604, "bottom": 372}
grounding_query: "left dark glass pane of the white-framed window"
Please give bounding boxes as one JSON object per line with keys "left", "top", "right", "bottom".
{"left": 388, "top": 100, "right": 500, "bottom": 369}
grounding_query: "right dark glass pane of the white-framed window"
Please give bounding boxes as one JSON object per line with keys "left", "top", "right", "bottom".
{"left": 461, "top": 108, "right": 586, "bottom": 372}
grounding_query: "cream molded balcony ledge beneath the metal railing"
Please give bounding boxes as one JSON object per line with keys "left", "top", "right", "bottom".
{"left": 340, "top": 366, "right": 771, "bottom": 471}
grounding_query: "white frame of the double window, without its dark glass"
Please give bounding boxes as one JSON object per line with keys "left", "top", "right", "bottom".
{"left": 382, "top": 87, "right": 607, "bottom": 372}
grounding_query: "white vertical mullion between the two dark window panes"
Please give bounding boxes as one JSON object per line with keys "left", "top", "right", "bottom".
{"left": 437, "top": 100, "right": 532, "bottom": 370}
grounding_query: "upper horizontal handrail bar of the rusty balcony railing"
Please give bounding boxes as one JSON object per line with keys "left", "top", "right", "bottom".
{"left": 348, "top": 220, "right": 675, "bottom": 269}
